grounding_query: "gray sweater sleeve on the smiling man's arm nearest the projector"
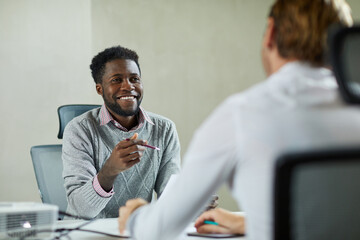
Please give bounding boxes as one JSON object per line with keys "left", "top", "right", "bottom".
{"left": 62, "top": 118, "right": 112, "bottom": 218}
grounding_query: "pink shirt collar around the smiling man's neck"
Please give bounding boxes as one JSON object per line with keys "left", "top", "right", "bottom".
{"left": 100, "top": 104, "right": 155, "bottom": 132}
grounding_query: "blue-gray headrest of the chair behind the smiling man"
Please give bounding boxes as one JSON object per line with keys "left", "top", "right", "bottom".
{"left": 58, "top": 104, "right": 101, "bottom": 139}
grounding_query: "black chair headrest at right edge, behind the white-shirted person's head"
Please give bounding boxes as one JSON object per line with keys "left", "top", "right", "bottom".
{"left": 328, "top": 25, "right": 360, "bottom": 104}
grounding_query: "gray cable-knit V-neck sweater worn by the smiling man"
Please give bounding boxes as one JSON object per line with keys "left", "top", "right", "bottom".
{"left": 62, "top": 108, "right": 180, "bottom": 218}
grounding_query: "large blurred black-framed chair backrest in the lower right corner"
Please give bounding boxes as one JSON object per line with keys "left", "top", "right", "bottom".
{"left": 274, "top": 146, "right": 360, "bottom": 240}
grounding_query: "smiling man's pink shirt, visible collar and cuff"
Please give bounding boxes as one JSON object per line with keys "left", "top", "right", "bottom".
{"left": 93, "top": 104, "right": 155, "bottom": 198}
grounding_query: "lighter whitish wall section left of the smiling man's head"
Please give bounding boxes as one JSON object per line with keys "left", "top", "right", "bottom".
{"left": 0, "top": 0, "right": 98, "bottom": 201}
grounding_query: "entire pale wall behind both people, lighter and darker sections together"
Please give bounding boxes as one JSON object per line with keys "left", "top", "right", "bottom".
{"left": 0, "top": 0, "right": 360, "bottom": 210}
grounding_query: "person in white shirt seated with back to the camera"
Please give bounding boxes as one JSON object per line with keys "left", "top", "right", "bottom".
{"left": 119, "top": 0, "right": 360, "bottom": 240}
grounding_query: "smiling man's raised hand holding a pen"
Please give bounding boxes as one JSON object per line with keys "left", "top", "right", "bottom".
{"left": 98, "top": 133, "right": 147, "bottom": 191}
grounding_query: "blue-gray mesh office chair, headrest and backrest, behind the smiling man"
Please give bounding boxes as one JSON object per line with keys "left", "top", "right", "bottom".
{"left": 30, "top": 105, "right": 100, "bottom": 219}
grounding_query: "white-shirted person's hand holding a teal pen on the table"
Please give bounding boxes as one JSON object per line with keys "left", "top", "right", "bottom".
{"left": 195, "top": 208, "right": 245, "bottom": 234}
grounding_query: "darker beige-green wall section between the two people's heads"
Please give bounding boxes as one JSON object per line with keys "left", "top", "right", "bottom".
{"left": 92, "top": 0, "right": 272, "bottom": 209}
